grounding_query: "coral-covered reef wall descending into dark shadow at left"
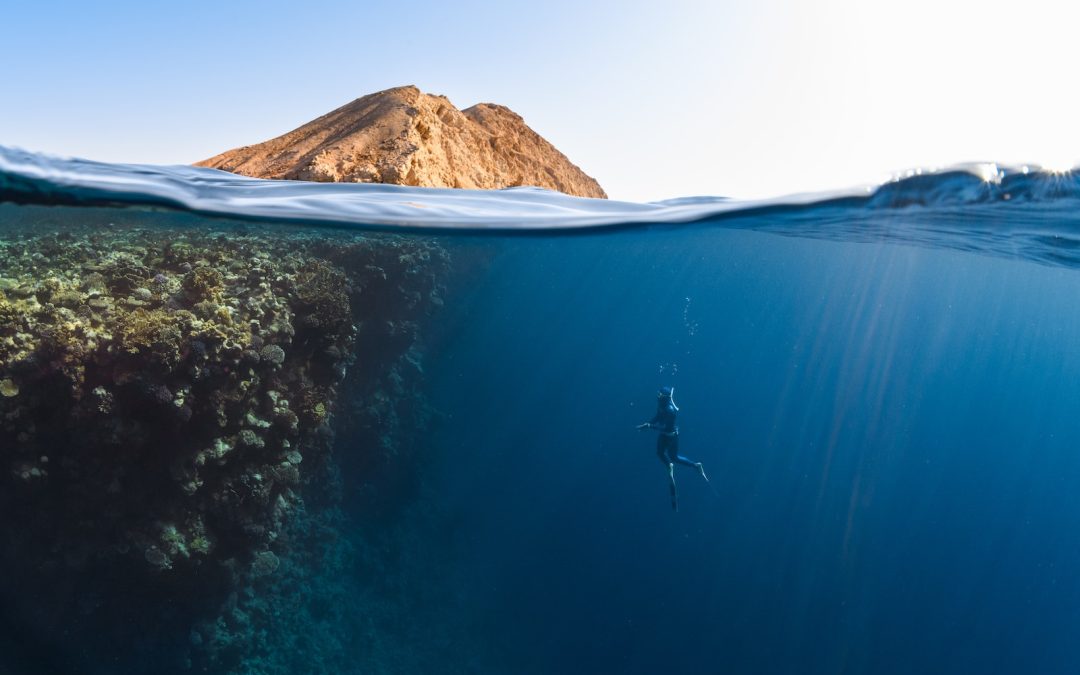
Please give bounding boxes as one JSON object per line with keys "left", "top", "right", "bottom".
{"left": 0, "top": 206, "right": 448, "bottom": 674}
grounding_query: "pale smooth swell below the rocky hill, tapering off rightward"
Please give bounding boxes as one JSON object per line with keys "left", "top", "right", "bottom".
{"left": 0, "top": 147, "right": 733, "bottom": 230}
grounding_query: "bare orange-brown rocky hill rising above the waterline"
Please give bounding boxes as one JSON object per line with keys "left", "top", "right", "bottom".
{"left": 198, "top": 86, "right": 607, "bottom": 198}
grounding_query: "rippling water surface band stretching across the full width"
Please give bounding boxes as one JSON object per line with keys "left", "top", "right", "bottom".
{"left": 0, "top": 146, "right": 1080, "bottom": 266}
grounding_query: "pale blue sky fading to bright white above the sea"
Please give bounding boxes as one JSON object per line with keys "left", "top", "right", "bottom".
{"left": 0, "top": 0, "right": 1080, "bottom": 201}
